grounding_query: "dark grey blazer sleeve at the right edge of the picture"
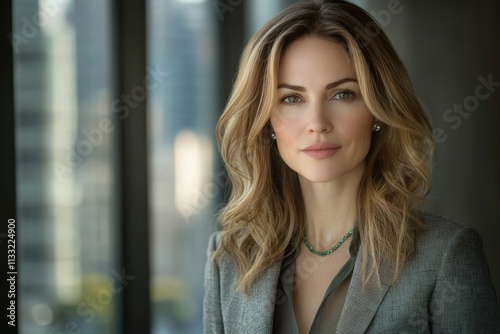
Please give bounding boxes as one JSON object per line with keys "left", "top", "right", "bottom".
{"left": 429, "top": 228, "right": 500, "bottom": 334}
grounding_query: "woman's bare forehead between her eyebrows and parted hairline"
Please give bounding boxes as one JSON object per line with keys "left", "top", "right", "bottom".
{"left": 278, "top": 37, "right": 356, "bottom": 84}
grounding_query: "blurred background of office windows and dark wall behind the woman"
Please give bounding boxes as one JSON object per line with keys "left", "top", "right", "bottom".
{"left": 2, "top": 0, "right": 500, "bottom": 334}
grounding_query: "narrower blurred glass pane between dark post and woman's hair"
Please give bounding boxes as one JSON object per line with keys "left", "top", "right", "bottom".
{"left": 148, "top": 0, "right": 219, "bottom": 333}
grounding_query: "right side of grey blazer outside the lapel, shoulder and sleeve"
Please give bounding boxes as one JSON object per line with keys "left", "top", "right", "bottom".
{"left": 371, "top": 217, "right": 500, "bottom": 333}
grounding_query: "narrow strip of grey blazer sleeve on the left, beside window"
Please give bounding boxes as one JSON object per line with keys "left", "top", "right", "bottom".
{"left": 203, "top": 232, "right": 224, "bottom": 334}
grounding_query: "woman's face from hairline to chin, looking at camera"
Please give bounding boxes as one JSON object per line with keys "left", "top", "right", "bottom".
{"left": 271, "top": 37, "right": 374, "bottom": 182}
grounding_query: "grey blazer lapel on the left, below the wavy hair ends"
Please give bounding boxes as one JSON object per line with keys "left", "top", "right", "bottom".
{"left": 238, "top": 261, "right": 281, "bottom": 334}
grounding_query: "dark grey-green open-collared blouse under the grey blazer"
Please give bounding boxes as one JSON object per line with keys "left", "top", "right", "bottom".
{"left": 273, "top": 234, "right": 358, "bottom": 334}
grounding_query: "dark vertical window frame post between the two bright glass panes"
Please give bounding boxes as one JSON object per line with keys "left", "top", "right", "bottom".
{"left": 112, "top": 0, "right": 151, "bottom": 334}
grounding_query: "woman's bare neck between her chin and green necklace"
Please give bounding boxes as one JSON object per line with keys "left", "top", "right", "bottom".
{"left": 299, "top": 165, "right": 363, "bottom": 248}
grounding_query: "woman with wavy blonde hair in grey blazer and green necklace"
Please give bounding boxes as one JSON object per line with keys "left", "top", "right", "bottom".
{"left": 204, "top": 0, "right": 500, "bottom": 333}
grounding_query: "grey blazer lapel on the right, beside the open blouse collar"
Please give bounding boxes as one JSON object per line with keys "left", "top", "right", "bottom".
{"left": 336, "top": 249, "right": 394, "bottom": 333}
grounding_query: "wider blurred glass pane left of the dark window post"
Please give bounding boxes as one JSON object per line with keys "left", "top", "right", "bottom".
{"left": 13, "top": 0, "right": 117, "bottom": 334}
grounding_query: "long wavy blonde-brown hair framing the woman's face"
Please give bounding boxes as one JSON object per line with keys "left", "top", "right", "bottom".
{"left": 215, "top": 0, "right": 434, "bottom": 292}
